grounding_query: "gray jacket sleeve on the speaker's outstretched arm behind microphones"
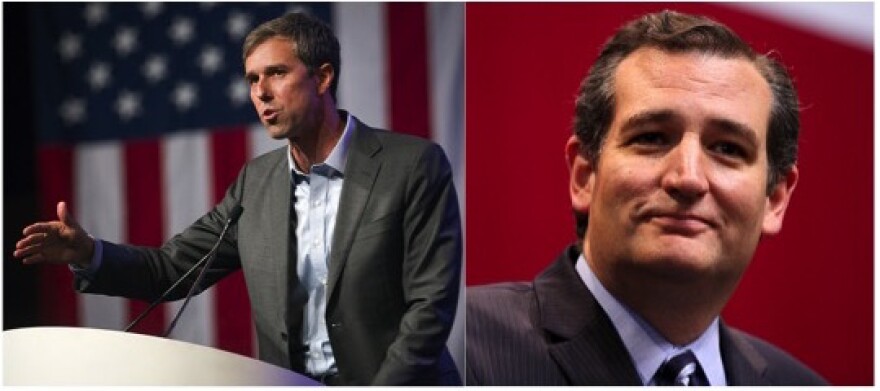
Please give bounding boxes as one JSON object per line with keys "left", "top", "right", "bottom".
{"left": 74, "top": 164, "right": 247, "bottom": 301}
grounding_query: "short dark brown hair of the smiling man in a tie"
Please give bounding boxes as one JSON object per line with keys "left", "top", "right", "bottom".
{"left": 574, "top": 10, "right": 800, "bottom": 241}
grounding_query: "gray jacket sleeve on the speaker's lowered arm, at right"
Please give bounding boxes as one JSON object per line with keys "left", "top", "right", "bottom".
{"left": 373, "top": 144, "right": 462, "bottom": 384}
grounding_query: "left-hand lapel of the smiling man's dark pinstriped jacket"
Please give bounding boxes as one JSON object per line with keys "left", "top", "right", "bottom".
{"left": 535, "top": 247, "right": 642, "bottom": 385}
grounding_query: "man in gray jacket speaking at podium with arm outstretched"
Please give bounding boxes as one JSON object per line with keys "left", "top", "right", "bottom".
{"left": 15, "top": 13, "right": 462, "bottom": 385}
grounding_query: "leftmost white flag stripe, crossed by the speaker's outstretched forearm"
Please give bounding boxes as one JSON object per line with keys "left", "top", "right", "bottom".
{"left": 73, "top": 142, "right": 128, "bottom": 330}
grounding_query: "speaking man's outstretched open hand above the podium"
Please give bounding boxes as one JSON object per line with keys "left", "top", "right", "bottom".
{"left": 12, "top": 201, "right": 95, "bottom": 267}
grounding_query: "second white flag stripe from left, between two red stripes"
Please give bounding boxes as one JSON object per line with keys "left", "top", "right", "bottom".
{"left": 162, "top": 132, "right": 216, "bottom": 346}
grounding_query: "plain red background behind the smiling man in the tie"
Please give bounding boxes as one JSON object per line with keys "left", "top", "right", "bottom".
{"left": 466, "top": 3, "right": 874, "bottom": 385}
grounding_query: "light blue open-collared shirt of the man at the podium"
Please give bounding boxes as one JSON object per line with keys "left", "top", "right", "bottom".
{"left": 287, "top": 114, "right": 354, "bottom": 375}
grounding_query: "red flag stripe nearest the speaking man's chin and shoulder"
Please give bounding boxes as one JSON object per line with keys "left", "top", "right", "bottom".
{"left": 209, "top": 127, "right": 254, "bottom": 356}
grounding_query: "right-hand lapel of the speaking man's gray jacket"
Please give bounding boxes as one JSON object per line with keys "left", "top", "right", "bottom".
{"left": 327, "top": 120, "right": 382, "bottom": 303}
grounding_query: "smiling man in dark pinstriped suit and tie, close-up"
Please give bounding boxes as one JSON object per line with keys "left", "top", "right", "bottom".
{"left": 466, "top": 11, "right": 825, "bottom": 385}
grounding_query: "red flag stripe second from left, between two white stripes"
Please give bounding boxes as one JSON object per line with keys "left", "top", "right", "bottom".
{"left": 123, "top": 139, "right": 166, "bottom": 335}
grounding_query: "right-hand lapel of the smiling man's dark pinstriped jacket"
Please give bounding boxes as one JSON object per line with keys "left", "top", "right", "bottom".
{"left": 719, "top": 322, "right": 772, "bottom": 386}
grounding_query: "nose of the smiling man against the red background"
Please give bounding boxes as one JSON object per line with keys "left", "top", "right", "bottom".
{"left": 661, "top": 137, "right": 709, "bottom": 202}
